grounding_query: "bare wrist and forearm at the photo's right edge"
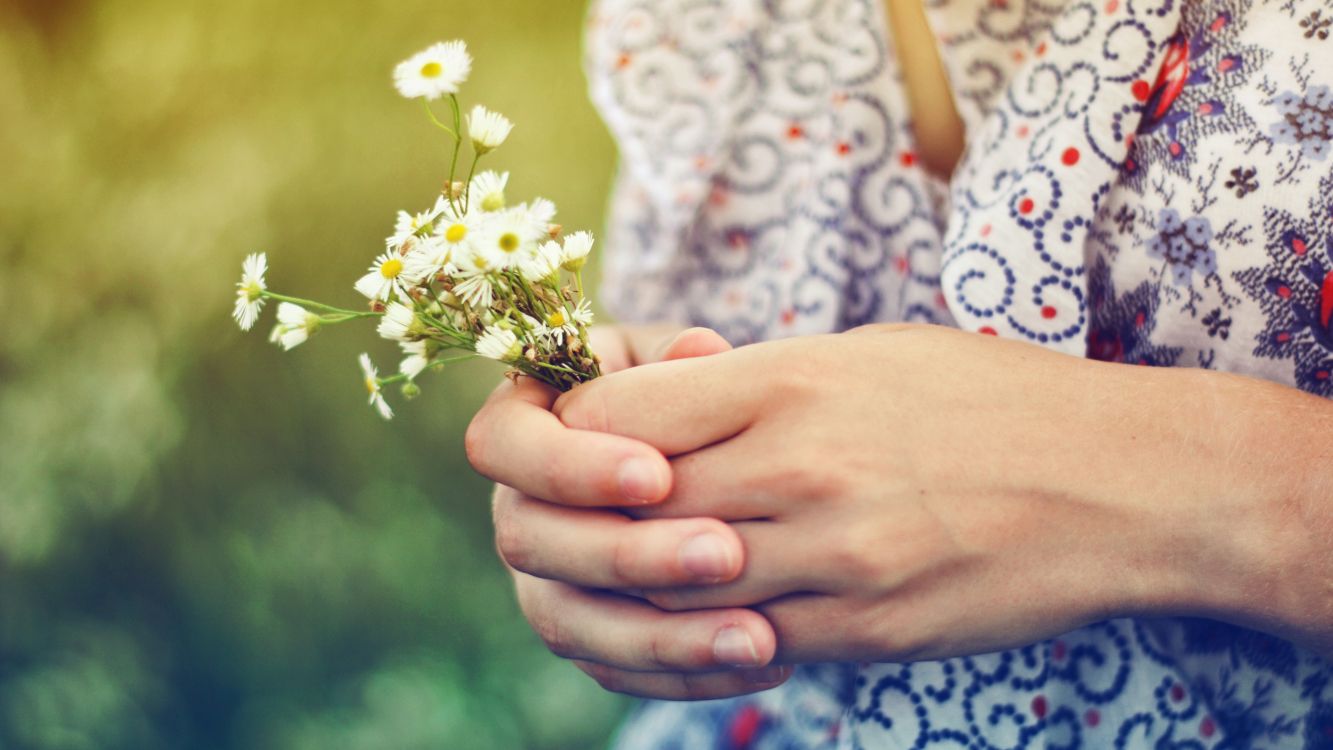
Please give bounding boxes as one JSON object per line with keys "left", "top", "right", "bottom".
{"left": 1130, "top": 370, "right": 1333, "bottom": 646}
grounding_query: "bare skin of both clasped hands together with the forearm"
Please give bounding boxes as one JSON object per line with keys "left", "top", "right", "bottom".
{"left": 468, "top": 326, "right": 1333, "bottom": 699}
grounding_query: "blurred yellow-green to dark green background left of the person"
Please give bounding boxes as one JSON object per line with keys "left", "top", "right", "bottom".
{"left": 0, "top": 0, "right": 625, "bottom": 750}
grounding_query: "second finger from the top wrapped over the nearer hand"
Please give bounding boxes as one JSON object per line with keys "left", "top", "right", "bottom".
{"left": 493, "top": 490, "right": 745, "bottom": 589}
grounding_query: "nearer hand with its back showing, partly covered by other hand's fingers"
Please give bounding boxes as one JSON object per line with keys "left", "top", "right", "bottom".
{"left": 549, "top": 326, "right": 1264, "bottom": 667}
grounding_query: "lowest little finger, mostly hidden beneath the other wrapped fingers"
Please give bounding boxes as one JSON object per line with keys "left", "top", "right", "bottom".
{"left": 575, "top": 661, "right": 792, "bottom": 701}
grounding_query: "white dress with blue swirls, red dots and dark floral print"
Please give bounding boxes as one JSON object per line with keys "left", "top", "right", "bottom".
{"left": 588, "top": 0, "right": 1333, "bottom": 750}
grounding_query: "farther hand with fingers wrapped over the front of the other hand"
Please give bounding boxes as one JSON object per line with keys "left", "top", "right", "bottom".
{"left": 467, "top": 328, "right": 789, "bottom": 698}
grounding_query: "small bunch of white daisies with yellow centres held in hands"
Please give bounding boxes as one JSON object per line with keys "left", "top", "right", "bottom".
{"left": 233, "top": 41, "right": 600, "bottom": 418}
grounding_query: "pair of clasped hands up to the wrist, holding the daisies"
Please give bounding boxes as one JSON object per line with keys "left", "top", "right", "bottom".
{"left": 467, "top": 326, "right": 1210, "bottom": 699}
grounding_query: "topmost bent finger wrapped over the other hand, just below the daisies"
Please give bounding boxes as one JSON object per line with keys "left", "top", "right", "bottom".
{"left": 465, "top": 377, "right": 670, "bottom": 506}
